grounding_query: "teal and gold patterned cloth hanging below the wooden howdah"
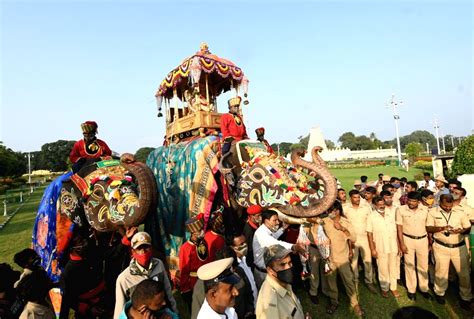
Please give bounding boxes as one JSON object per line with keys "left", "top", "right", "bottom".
{"left": 145, "top": 136, "right": 219, "bottom": 257}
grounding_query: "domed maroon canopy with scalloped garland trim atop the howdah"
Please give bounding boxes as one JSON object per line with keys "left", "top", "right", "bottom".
{"left": 155, "top": 43, "right": 248, "bottom": 100}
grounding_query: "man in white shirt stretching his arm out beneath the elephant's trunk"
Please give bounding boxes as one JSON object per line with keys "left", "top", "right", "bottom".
{"left": 252, "top": 209, "right": 305, "bottom": 288}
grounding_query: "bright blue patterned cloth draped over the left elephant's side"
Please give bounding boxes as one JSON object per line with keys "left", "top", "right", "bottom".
{"left": 32, "top": 172, "right": 74, "bottom": 282}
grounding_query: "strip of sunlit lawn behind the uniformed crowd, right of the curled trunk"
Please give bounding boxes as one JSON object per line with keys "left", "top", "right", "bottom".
{"left": 330, "top": 166, "right": 430, "bottom": 191}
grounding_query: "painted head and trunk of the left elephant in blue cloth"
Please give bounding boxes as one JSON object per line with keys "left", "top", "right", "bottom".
{"left": 58, "top": 156, "right": 157, "bottom": 232}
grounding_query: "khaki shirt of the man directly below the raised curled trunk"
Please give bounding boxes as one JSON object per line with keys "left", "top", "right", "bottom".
{"left": 311, "top": 217, "right": 354, "bottom": 264}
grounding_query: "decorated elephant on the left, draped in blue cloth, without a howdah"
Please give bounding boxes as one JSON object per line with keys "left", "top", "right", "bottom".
{"left": 32, "top": 154, "right": 157, "bottom": 282}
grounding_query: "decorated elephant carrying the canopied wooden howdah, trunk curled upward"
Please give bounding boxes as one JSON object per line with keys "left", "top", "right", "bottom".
{"left": 145, "top": 136, "right": 337, "bottom": 257}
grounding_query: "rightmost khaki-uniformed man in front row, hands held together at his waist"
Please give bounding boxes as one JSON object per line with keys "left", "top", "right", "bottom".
{"left": 426, "top": 194, "right": 472, "bottom": 309}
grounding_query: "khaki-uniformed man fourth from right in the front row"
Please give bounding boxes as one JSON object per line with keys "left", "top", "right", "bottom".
{"left": 343, "top": 190, "right": 377, "bottom": 294}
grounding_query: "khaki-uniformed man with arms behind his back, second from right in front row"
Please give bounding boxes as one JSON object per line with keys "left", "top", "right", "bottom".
{"left": 396, "top": 191, "right": 432, "bottom": 300}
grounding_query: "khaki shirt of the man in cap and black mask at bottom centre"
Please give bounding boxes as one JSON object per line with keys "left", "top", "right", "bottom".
{"left": 255, "top": 275, "right": 304, "bottom": 319}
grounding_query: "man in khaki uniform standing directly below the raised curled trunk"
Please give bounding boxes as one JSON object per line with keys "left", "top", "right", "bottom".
{"left": 310, "top": 202, "right": 364, "bottom": 316}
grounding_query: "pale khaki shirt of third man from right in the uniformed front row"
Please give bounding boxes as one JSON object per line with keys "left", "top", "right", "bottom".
{"left": 367, "top": 210, "right": 398, "bottom": 254}
